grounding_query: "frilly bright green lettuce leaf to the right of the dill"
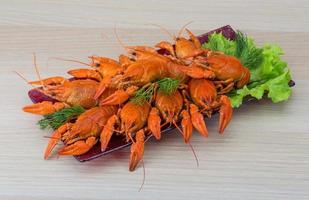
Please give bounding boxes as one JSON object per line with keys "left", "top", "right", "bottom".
{"left": 229, "top": 44, "right": 292, "bottom": 107}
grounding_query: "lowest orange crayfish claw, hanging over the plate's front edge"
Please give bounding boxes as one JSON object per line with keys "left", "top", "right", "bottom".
{"left": 129, "top": 130, "right": 145, "bottom": 171}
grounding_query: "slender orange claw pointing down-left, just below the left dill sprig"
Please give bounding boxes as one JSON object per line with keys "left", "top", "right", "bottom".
{"left": 44, "top": 123, "right": 72, "bottom": 159}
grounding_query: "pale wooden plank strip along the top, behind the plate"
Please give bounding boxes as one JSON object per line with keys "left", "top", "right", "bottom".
{"left": 0, "top": 0, "right": 309, "bottom": 32}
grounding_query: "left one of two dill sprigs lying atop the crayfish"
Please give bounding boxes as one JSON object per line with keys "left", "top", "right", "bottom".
{"left": 131, "top": 83, "right": 155, "bottom": 105}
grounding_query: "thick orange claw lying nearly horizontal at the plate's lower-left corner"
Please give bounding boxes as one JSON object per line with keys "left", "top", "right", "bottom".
{"left": 58, "top": 136, "right": 98, "bottom": 156}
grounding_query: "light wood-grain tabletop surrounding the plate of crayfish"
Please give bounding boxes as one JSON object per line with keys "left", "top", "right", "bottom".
{"left": 0, "top": 0, "right": 309, "bottom": 200}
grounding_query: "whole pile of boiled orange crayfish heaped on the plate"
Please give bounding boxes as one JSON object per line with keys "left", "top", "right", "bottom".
{"left": 23, "top": 29, "right": 250, "bottom": 171}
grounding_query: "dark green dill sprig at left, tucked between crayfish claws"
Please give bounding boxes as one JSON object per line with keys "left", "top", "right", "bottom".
{"left": 38, "top": 106, "right": 85, "bottom": 129}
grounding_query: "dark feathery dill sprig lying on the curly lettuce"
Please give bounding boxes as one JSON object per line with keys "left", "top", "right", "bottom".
{"left": 235, "top": 31, "right": 263, "bottom": 69}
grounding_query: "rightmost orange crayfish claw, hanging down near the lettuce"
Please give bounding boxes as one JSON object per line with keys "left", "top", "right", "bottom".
{"left": 219, "top": 95, "right": 233, "bottom": 134}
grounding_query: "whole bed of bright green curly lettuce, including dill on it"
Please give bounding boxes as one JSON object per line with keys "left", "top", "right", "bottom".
{"left": 203, "top": 32, "right": 292, "bottom": 108}
